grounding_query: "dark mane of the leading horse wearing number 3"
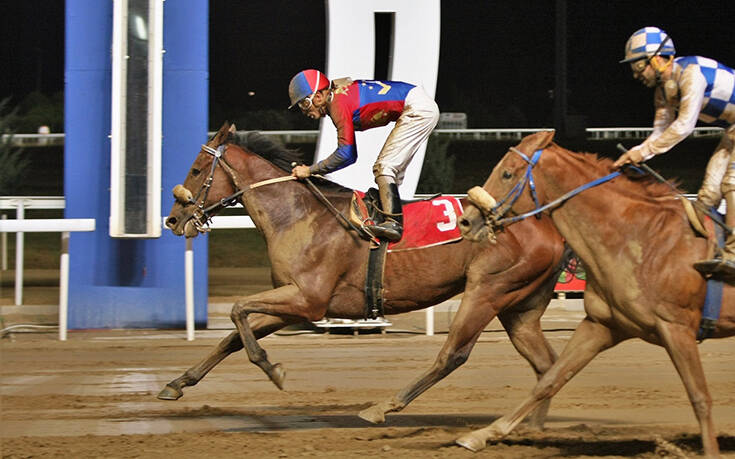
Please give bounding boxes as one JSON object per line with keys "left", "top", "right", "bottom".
{"left": 227, "top": 131, "right": 352, "bottom": 193}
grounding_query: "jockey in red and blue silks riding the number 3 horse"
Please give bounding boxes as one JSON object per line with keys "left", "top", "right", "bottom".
{"left": 288, "top": 69, "right": 439, "bottom": 241}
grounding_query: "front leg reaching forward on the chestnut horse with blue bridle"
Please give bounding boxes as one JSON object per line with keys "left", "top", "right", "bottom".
{"left": 456, "top": 318, "right": 622, "bottom": 451}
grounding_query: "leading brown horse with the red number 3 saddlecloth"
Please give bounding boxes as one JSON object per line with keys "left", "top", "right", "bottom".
{"left": 158, "top": 123, "right": 566, "bottom": 425}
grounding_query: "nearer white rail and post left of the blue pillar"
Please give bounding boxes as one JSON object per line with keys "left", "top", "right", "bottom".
{"left": 0, "top": 218, "right": 95, "bottom": 341}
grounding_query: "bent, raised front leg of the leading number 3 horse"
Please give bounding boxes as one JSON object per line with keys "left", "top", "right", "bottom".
{"left": 230, "top": 285, "right": 326, "bottom": 390}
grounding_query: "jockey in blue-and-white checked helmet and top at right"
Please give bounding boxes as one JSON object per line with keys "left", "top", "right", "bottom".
{"left": 614, "top": 27, "right": 735, "bottom": 277}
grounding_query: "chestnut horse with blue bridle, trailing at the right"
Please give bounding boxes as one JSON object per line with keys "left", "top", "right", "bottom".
{"left": 457, "top": 132, "right": 735, "bottom": 457}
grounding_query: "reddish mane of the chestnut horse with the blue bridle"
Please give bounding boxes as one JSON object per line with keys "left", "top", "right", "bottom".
{"left": 554, "top": 144, "right": 684, "bottom": 198}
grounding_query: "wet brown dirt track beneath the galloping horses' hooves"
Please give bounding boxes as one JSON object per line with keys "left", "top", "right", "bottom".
{"left": 0, "top": 331, "right": 735, "bottom": 458}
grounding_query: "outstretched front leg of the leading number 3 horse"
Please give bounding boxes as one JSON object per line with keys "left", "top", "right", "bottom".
{"left": 158, "top": 315, "right": 289, "bottom": 400}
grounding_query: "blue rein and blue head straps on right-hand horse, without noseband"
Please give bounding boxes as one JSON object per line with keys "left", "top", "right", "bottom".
{"left": 490, "top": 147, "right": 637, "bottom": 226}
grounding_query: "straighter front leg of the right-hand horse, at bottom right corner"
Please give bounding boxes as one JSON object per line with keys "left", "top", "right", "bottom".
{"left": 656, "top": 320, "right": 720, "bottom": 457}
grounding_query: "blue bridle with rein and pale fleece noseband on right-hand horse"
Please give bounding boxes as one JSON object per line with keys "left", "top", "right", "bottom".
{"left": 470, "top": 147, "right": 620, "bottom": 228}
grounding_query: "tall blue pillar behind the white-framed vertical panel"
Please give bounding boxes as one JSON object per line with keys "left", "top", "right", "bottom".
{"left": 64, "top": 0, "right": 208, "bottom": 329}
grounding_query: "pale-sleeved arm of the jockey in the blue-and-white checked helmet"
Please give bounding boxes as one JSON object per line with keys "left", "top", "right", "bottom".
{"left": 643, "top": 66, "right": 707, "bottom": 155}
